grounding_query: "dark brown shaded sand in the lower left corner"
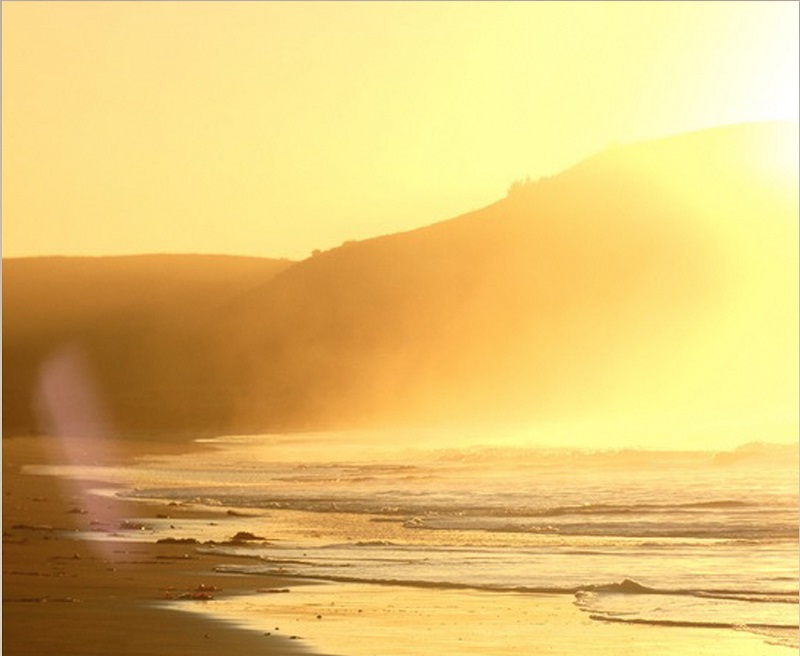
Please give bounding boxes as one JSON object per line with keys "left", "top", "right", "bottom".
{"left": 3, "top": 438, "right": 324, "bottom": 656}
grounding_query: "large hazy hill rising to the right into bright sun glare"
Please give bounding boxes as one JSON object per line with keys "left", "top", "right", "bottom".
{"left": 216, "top": 124, "right": 798, "bottom": 430}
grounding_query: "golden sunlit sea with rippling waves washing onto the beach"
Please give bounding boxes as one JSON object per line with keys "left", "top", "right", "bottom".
{"left": 39, "top": 433, "right": 798, "bottom": 656}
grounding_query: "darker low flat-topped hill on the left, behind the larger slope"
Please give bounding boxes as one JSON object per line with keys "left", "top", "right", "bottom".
{"left": 3, "top": 255, "right": 291, "bottom": 435}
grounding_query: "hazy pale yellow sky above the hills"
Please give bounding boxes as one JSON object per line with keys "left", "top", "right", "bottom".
{"left": 2, "top": 0, "right": 800, "bottom": 258}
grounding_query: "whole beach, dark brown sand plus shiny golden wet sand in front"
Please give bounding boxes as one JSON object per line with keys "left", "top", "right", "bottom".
{"left": 3, "top": 437, "right": 788, "bottom": 656}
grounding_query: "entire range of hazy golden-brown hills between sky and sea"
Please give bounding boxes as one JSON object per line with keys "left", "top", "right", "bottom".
{"left": 3, "top": 124, "right": 798, "bottom": 439}
